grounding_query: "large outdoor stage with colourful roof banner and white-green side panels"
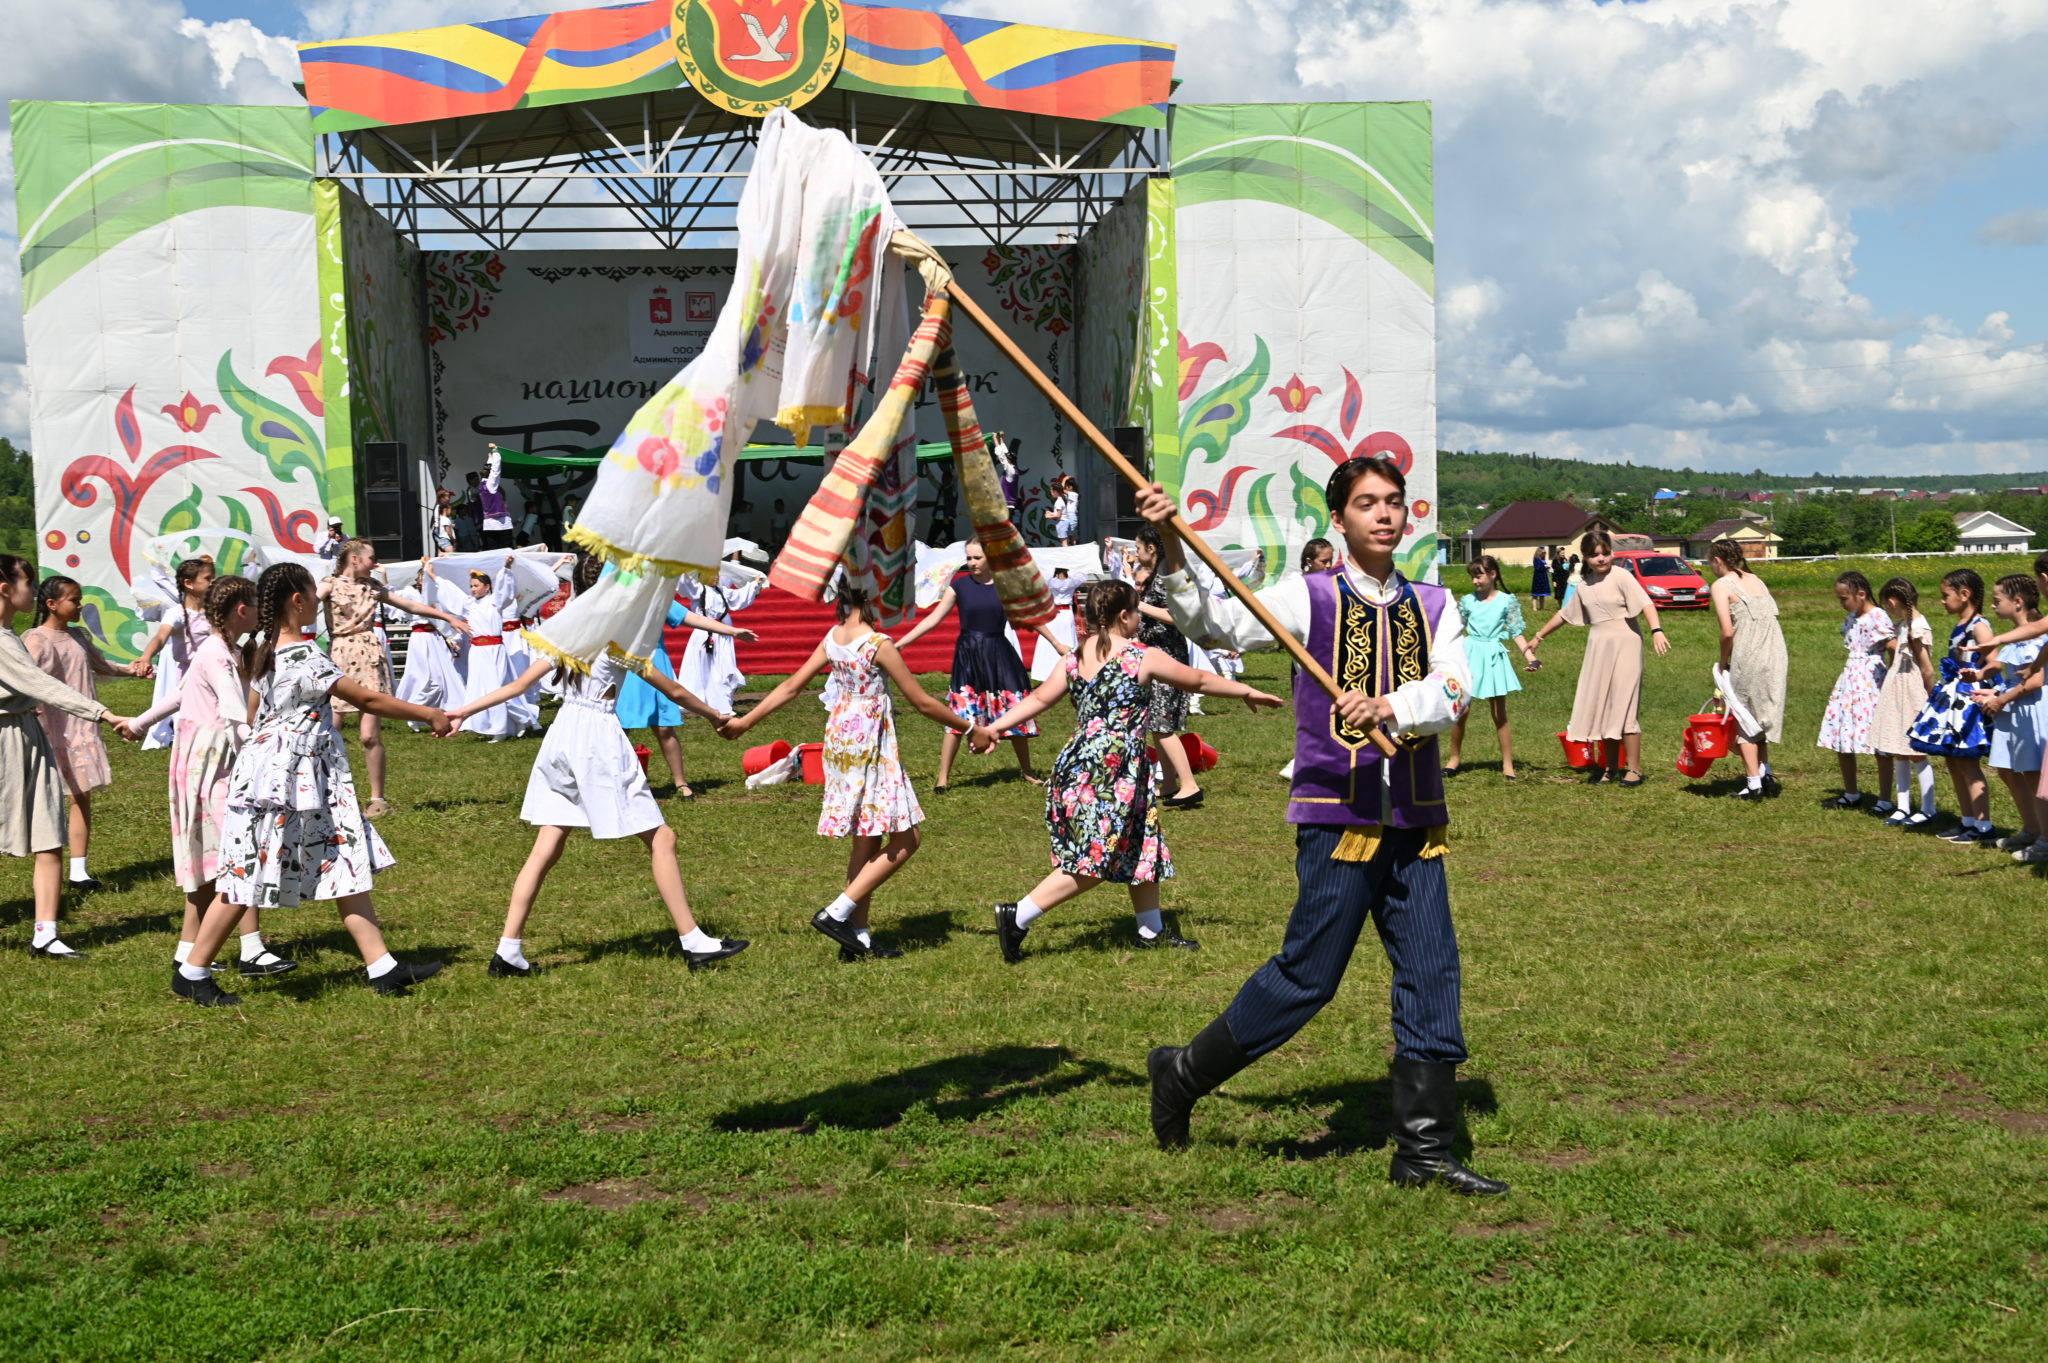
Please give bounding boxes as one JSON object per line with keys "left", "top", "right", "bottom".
{"left": 12, "top": 0, "right": 1436, "bottom": 659}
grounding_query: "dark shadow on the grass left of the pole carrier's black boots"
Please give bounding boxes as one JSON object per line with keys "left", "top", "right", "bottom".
{"left": 711, "top": 1046, "right": 1141, "bottom": 1136}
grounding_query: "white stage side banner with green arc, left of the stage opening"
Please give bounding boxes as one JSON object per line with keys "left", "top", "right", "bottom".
{"left": 12, "top": 100, "right": 335, "bottom": 659}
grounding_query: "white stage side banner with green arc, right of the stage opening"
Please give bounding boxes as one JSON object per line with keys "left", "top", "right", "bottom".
{"left": 1153, "top": 104, "right": 1438, "bottom": 577}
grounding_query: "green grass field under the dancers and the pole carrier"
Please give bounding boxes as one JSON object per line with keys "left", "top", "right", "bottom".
{"left": 0, "top": 556, "right": 2048, "bottom": 1361}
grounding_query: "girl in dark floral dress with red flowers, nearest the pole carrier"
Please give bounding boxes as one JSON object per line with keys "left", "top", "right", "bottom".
{"left": 987, "top": 581, "right": 1280, "bottom": 964}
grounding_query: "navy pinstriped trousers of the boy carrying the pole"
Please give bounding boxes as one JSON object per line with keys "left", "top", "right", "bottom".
{"left": 1225, "top": 823, "right": 1464, "bottom": 1064}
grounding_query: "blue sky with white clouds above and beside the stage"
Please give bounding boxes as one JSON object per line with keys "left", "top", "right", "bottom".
{"left": 0, "top": 0, "right": 2048, "bottom": 473}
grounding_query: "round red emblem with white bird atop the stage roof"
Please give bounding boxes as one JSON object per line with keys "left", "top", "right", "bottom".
{"left": 670, "top": 0, "right": 846, "bottom": 119}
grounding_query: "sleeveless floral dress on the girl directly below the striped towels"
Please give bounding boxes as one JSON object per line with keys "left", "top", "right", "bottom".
{"left": 817, "top": 634, "right": 924, "bottom": 837}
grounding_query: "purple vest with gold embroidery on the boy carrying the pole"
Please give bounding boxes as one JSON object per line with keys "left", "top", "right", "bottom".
{"left": 1286, "top": 569, "right": 1450, "bottom": 829}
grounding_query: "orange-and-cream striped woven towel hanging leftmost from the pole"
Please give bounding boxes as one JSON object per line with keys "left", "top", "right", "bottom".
{"left": 768, "top": 293, "right": 952, "bottom": 624}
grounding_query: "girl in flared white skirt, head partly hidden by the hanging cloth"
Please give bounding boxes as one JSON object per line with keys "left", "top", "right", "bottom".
{"left": 453, "top": 555, "right": 748, "bottom": 965}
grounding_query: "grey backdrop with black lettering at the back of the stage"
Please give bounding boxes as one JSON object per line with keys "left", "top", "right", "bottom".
{"left": 424, "top": 246, "right": 1081, "bottom": 546}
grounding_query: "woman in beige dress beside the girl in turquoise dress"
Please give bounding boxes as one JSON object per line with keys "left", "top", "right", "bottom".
{"left": 1530, "top": 530, "right": 1671, "bottom": 786}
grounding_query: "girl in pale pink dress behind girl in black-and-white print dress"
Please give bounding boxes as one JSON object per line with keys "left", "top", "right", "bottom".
{"left": 123, "top": 575, "right": 299, "bottom": 978}
